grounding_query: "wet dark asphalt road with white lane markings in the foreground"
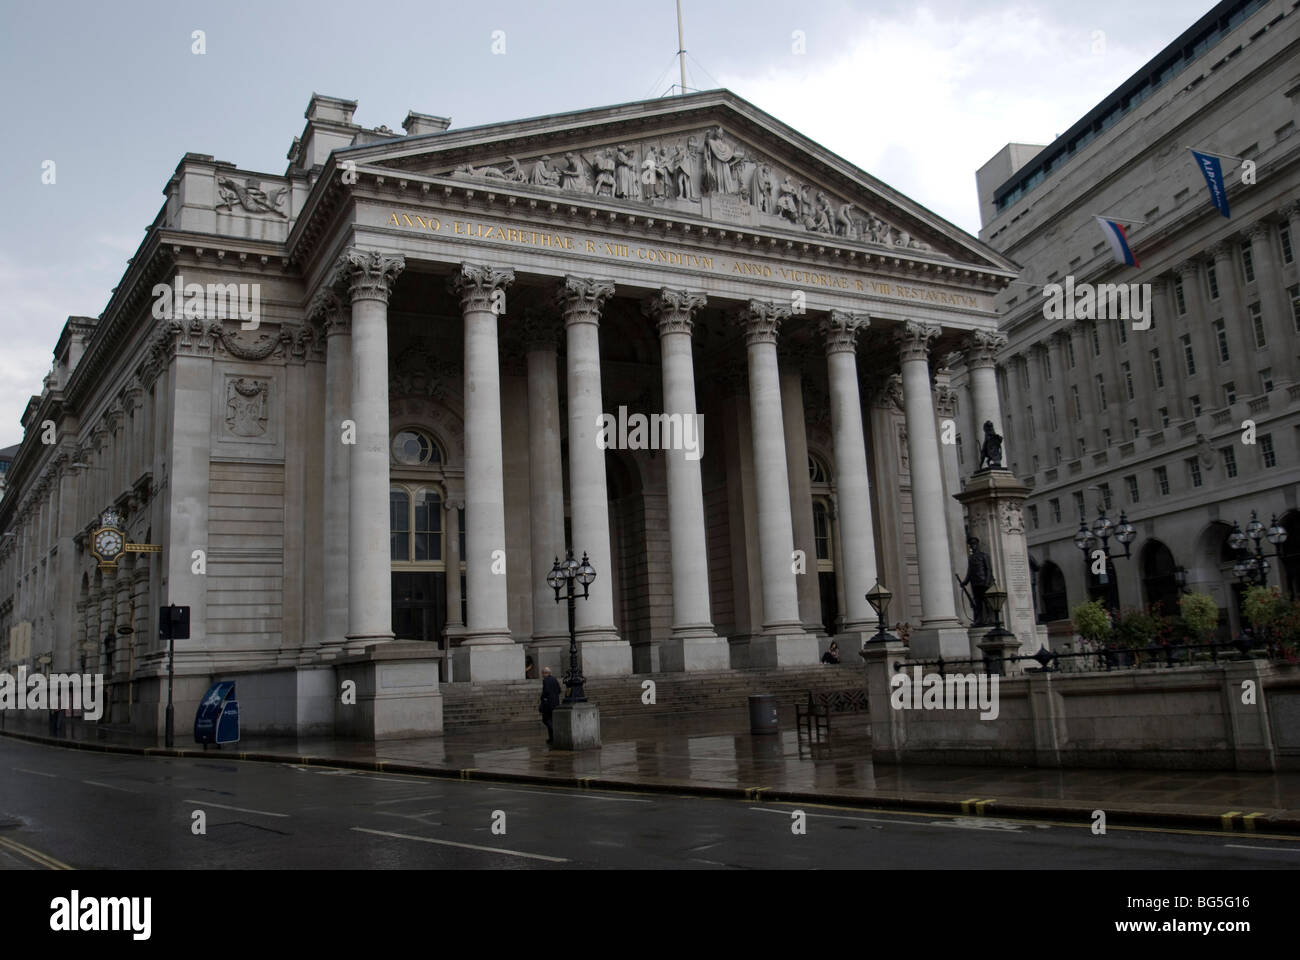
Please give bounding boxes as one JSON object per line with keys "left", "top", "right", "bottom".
{"left": 0, "top": 739, "right": 1300, "bottom": 869}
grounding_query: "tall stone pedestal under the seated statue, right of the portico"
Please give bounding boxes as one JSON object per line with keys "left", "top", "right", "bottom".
{"left": 956, "top": 470, "right": 1039, "bottom": 653}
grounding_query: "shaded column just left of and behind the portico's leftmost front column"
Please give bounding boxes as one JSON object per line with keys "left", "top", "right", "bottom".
{"left": 308, "top": 286, "right": 351, "bottom": 660}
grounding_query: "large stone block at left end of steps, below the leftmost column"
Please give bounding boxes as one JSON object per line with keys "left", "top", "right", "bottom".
{"left": 332, "top": 641, "right": 442, "bottom": 740}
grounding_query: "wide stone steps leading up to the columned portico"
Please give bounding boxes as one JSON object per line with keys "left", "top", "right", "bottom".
{"left": 439, "top": 663, "right": 866, "bottom": 727}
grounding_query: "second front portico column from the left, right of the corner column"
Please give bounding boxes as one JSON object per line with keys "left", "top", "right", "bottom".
{"left": 451, "top": 263, "right": 524, "bottom": 683}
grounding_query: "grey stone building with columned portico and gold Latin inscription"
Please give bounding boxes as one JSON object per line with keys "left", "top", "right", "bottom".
{"left": 0, "top": 91, "right": 1015, "bottom": 731}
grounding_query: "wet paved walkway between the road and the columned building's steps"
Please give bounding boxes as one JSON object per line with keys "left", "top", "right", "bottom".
{"left": 0, "top": 709, "right": 1300, "bottom": 833}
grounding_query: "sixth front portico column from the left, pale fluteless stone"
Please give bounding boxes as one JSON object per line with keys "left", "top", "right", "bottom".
{"left": 820, "top": 310, "right": 876, "bottom": 632}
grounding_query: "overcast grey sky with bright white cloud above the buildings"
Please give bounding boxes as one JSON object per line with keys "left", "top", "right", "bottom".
{"left": 0, "top": 0, "right": 1212, "bottom": 446}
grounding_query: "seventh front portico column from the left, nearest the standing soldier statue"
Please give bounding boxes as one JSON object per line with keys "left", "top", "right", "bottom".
{"left": 885, "top": 320, "right": 970, "bottom": 660}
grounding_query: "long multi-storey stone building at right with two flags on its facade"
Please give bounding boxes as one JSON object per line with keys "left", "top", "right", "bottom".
{"left": 954, "top": 0, "right": 1300, "bottom": 633}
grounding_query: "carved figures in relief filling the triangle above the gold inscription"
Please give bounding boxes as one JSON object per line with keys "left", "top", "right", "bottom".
{"left": 447, "top": 126, "right": 931, "bottom": 251}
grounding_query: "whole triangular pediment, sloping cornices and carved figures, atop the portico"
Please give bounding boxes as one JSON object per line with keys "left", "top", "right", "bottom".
{"left": 341, "top": 90, "right": 1017, "bottom": 272}
